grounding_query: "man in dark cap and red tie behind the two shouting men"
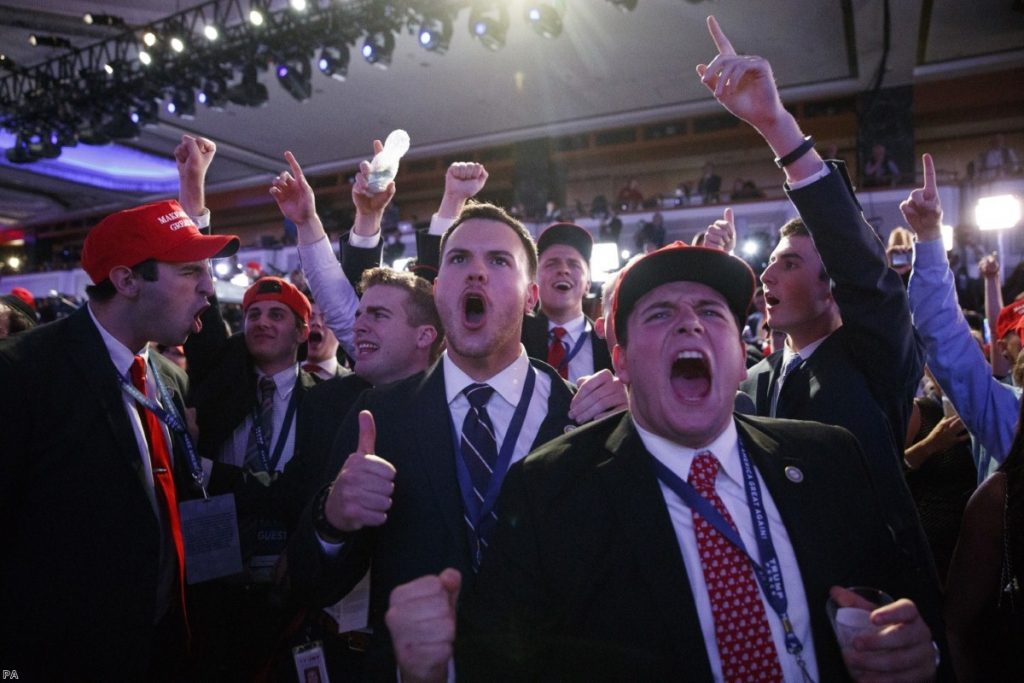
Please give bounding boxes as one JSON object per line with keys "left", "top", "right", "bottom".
{"left": 522, "top": 223, "right": 611, "bottom": 382}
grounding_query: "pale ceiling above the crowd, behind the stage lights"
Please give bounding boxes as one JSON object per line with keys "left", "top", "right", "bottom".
{"left": 0, "top": 0, "right": 1024, "bottom": 227}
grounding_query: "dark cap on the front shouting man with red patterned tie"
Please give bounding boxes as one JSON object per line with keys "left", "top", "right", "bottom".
{"left": 611, "top": 242, "right": 756, "bottom": 340}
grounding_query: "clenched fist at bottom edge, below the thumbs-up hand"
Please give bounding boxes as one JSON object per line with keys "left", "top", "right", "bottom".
{"left": 384, "top": 568, "right": 462, "bottom": 683}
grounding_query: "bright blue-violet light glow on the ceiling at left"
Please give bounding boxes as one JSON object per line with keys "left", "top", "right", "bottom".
{"left": 0, "top": 131, "right": 178, "bottom": 194}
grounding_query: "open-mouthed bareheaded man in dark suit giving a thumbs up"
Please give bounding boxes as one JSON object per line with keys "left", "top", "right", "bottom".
{"left": 289, "top": 205, "right": 571, "bottom": 680}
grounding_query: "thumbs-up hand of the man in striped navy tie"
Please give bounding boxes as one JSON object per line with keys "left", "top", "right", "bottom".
{"left": 324, "top": 411, "right": 395, "bottom": 531}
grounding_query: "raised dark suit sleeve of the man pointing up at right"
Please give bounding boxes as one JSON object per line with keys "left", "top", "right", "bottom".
{"left": 786, "top": 162, "right": 924, "bottom": 444}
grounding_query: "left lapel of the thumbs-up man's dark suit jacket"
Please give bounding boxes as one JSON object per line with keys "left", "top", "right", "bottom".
{"left": 414, "top": 360, "right": 469, "bottom": 566}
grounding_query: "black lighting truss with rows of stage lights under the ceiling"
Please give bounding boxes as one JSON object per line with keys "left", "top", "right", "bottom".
{"left": 0, "top": 0, "right": 637, "bottom": 161}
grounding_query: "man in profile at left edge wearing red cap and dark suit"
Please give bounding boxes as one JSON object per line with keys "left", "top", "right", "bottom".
{"left": 0, "top": 196, "right": 239, "bottom": 680}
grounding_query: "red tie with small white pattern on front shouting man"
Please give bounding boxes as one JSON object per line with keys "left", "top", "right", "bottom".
{"left": 687, "top": 451, "right": 782, "bottom": 682}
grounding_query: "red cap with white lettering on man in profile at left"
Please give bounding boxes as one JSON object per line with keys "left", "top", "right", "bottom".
{"left": 82, "top": 200, "right": 239, "bottom": 284}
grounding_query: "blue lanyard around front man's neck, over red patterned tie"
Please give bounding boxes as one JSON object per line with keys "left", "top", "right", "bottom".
{"left": 651, "top": 440, "right": 810, "bottom": 680}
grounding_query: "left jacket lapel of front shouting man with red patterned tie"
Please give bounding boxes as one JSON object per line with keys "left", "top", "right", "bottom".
{"left": 598, "top": 414, "right": 712, "bottom": 680}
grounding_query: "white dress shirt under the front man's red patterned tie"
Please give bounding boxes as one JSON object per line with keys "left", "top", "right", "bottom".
{"left": 634, "top": 421, "right": 825, "bottom": 681}
